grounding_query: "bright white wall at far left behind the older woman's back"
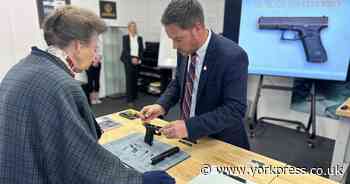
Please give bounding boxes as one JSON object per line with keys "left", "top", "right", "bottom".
{"left": 0, "top": 0, "right": 43, "bottom": 81}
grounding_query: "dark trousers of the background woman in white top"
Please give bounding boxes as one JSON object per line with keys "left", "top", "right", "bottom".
{"left": 124, "top": 62, "right": 139, "bottom": 103}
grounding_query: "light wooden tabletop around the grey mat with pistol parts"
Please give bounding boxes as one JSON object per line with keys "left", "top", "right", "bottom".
{"left": 99, "top": 109, "right": 336, "bottom": 184}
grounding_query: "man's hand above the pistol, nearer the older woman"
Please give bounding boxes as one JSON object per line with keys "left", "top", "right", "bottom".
{"left": 137, "top": 104, "right": 165, "bottom": 122}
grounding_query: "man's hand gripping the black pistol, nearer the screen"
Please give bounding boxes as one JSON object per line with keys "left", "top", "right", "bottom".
{"left": 160, "top": 120, "right": 188, "bottom": 139}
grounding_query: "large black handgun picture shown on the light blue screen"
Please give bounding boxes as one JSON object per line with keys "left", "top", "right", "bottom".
{"left": 258, "top": 16, "right": 328, "bottom": 63}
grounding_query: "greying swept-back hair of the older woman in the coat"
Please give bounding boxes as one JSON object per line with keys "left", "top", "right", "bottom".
{"left": 42, "top": 6, "right": 107, "bottom": 48}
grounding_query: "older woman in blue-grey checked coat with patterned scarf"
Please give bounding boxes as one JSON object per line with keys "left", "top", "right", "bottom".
{"left": 0, "top": 6, "right": 174, "bottom": 184}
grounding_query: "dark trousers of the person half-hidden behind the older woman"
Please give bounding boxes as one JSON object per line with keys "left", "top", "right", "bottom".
{"left": 86, "top": 64, "right": 101, "bottom": 93}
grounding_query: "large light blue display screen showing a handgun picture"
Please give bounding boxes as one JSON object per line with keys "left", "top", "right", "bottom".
{"left": 239, "top": 0, "right": 350, "bottom": 80}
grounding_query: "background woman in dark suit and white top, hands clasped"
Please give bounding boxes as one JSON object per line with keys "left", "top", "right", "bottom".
{"left": 120, "top": 21, "right": 143, "bottom": 107}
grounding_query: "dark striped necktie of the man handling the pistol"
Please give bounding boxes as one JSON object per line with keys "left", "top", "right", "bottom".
{"left": 181, "top": 53, "right": 198, "bottom": 121}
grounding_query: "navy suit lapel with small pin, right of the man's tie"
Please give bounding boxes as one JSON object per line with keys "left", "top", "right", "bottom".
{"left": 197, "top": 32, "right": 216, "bottom": 102}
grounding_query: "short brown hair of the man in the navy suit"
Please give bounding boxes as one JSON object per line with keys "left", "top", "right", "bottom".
{"left": 161, "top": 0, "right": 204, "bottom": 29}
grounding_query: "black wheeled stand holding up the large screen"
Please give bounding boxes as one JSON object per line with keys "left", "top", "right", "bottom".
{"left": 249, "top": 75, "right": 316, "bottom": 148}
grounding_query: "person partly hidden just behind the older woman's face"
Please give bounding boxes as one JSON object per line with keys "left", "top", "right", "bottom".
{"left": 86, "top": 40, "right": 103, "bottom": 104}
